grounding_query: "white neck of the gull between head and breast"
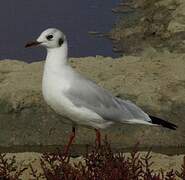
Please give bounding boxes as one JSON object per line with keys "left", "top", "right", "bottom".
{"left": 45, "top": 42, "right": 68, "bottom": 71}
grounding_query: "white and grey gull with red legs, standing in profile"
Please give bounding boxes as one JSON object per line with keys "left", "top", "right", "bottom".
{"left": 25, "top": 28, "right": 177, "bottom": 153}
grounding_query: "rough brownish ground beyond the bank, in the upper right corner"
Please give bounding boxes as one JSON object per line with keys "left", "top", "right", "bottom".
{"left": 110, "top": 0, "right": 185, "bottom": 55}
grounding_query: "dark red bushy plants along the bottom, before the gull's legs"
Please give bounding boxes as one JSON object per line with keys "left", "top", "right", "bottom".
{"left": 0, "top": 141, "right": 185, "bottom": 180}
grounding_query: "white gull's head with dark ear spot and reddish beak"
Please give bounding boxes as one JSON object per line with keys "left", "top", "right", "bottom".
{"left": 25, "top": 28, "right": 67, "bottom": 49}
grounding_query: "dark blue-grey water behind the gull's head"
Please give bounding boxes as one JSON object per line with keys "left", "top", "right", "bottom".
{"left": 0, "top": 0, "right": 121, "bottom": 62}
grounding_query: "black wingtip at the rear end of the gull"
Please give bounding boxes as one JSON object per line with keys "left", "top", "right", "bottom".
{"left": 149, "top": 116, "right": 177, "bottom": 130}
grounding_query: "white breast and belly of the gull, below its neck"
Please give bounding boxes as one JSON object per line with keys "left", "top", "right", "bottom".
{"left": 42, "top": 68, "right": 111, "bottom": 128}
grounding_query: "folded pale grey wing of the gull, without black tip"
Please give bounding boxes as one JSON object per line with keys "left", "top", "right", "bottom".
{"left": 65, "top": 74, "right": 150, "bottom": 122}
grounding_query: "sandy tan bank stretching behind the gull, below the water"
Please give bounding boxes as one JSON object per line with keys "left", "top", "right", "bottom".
{"left": 0, "top": 53, "right": 185, "bottom": 147}
